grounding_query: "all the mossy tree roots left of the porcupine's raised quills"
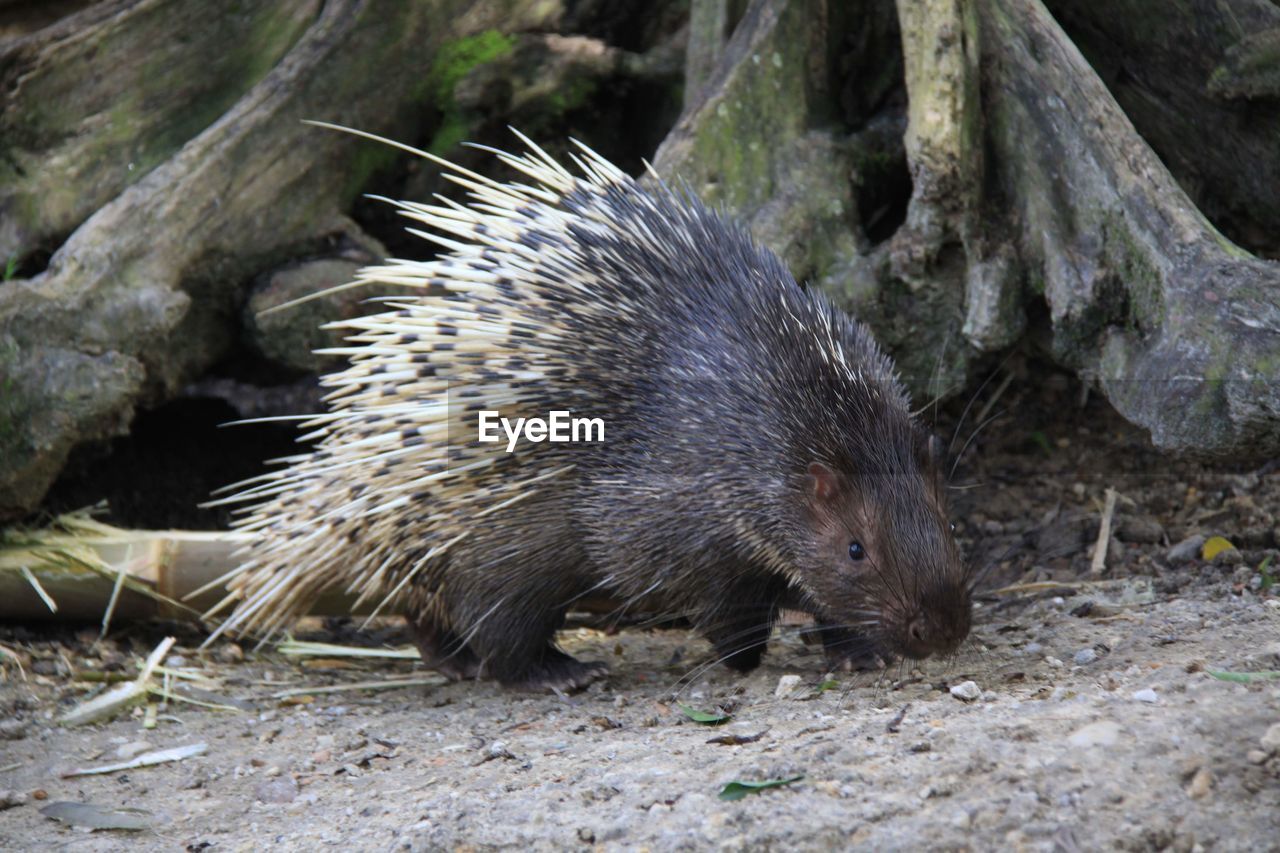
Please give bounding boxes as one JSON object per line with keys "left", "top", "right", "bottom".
{"left": 0, "top": 0, "right": 680, "bottom": 516}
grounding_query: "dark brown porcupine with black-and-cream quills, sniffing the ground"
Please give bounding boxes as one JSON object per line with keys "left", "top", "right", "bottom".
{"left": 210, "top": 122, "right": 970, "bottom": 688}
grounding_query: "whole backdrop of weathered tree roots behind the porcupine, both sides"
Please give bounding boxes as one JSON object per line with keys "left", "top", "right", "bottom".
{"left": 0, "top": 0, "right": 1280, "bottom": 516}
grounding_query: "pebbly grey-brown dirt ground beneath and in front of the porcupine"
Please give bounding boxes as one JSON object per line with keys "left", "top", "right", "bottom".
{"left": 0, "top": 380, "right": 1280, "bottom": 852}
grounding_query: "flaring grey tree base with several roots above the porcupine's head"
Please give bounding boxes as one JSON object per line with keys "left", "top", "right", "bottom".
{"left": 657, "top": 0, "right": 1280, "bottom": 457}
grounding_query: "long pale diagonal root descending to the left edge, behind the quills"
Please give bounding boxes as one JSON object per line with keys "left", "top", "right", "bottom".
{"left": 0, "top": 0, "right": 560, "bottom": 515}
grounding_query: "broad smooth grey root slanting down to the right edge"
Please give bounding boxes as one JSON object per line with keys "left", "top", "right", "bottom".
{"left": 978, "top": 0, "right": 1280, "bottom": 459}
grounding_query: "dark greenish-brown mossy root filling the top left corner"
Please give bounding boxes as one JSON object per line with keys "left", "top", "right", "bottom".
{"left": 0, "top": 0, "right": 321, "bottom": 260}
